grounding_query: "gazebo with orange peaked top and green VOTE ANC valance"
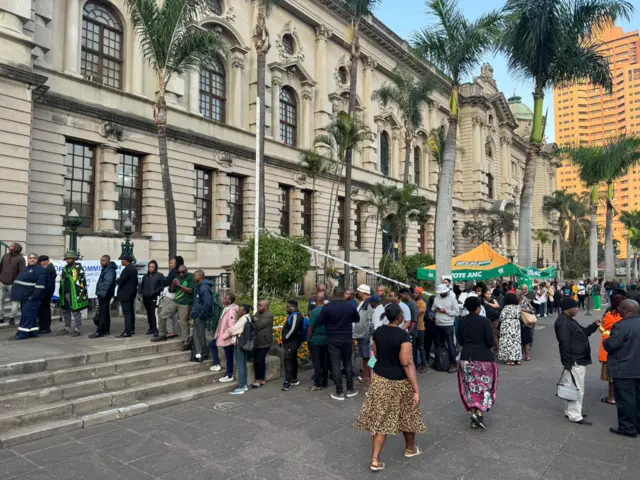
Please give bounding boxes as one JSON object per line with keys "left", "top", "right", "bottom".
{"left": 418, "top": 242, "right": 522, "bottom": 281}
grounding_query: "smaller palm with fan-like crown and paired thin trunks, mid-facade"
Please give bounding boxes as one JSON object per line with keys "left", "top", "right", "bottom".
{"left": 314, "top": 112, "right": 372, "bottom": 282}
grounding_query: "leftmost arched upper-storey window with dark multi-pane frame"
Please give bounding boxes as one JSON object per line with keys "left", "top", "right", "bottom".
{"left": 81, "top": 2, "right": 122, "bottom": 88}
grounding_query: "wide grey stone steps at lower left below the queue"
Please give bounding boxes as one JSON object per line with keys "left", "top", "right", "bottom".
{"left": 0, "top": 339, "right": 280, "bottom": 448}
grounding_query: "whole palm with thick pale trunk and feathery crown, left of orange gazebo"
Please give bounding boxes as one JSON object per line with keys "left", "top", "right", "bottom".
{"left": 412, "top": 0, "right": 501, "bottom": 280}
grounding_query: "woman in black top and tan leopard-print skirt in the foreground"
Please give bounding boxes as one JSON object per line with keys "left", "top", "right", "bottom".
{"left": 353, "top": 303, "right": 427, "bottom": 472}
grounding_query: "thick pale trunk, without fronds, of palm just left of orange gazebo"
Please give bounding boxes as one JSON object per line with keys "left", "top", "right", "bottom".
{"left": 435, "top": 116, "right": 458, "bottom": 284}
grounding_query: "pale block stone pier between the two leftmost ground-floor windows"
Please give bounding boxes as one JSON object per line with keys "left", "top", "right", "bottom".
{"left": 94, "top": 143, "right": 120, "bottom": 232}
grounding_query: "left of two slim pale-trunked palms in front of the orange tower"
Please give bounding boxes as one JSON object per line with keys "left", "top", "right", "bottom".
{"left": 559, "top": 146, "right": 606, "bottom": 278}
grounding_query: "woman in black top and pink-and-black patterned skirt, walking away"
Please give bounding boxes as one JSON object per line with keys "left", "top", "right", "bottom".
{"left": 457, "top": 297, "right": 499, "bottom": 430}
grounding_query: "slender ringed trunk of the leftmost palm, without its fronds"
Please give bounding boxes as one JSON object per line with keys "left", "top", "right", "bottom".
{"left": 154, "top": 91, "right": 178, "bottom": 260}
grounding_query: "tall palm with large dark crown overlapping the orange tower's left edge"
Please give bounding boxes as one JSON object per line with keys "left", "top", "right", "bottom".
{"left": 501, "top": 0, "right": 633, "bottom": 265}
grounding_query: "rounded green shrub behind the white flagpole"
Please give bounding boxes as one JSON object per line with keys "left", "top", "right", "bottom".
{"left": 233, "top": 234, "right": 311, "bottom": 298}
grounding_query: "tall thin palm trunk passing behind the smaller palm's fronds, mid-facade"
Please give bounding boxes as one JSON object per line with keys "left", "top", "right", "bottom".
{"left": 343, "top": 22, "right": 360, "bottom": 289}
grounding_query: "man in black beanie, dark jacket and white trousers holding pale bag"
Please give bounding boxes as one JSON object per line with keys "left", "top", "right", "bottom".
{"left": 554, "top": 297, "right": 599, "bottom": 425}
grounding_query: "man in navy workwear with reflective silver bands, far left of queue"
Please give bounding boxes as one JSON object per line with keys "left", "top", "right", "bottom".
{"left": 11, "top": 253, "right": 45, "bottom": 340}
